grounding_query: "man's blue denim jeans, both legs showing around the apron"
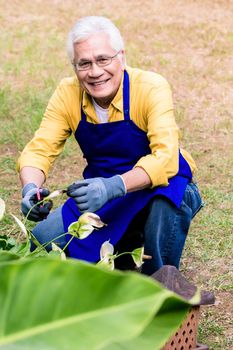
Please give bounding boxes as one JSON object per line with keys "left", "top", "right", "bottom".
{"left": 32, "top": 183, "right": 203, "bottom": 275}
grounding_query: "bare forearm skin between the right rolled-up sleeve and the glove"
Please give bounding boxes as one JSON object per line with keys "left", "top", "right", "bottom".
{"left": 121, "top": 167, "right": 151, "bottom": 192}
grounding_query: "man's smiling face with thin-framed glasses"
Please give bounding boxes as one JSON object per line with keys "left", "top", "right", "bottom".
{"left": 74, "top": 33, "right": 125, "bottom": 108}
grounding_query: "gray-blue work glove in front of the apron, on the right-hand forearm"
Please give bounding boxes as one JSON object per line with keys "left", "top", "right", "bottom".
{"left": 67, "top": 175, "right": 126, "bottom": 213}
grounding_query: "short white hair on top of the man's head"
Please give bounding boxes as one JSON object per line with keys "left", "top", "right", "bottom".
{"left": 67, "top": 16, "right": 124, "bottom": 63}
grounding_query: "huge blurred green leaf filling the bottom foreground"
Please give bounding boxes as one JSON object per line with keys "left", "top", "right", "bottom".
{"left": 0, "top": 258, "right": 190, "bottom": 350}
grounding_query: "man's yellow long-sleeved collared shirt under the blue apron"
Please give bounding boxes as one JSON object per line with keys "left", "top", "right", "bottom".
{"left": 17, "top": 67, "right": 196, "bottom": 187}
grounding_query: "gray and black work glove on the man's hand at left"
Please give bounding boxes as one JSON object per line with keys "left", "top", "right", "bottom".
{"left": 21, "top": 183, "right": 53, "bottom": 222}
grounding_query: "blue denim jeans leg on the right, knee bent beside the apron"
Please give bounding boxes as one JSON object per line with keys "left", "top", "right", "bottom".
{"left": 142, "top": 183, "right": 203, "bottom": 275}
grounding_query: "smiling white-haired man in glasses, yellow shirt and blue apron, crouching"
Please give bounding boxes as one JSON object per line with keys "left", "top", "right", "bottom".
{"left": 18, "top": 16, "right": 202, "bottom": 275}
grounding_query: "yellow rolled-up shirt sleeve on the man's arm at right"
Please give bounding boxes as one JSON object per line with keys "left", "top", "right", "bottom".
{"left": 135, "top": 77, "right": 179, "bottom": 187}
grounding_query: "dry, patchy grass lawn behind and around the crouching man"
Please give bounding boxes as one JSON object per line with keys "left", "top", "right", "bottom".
{"left": 0, "top": 0, "right": 233, "bottom": 350}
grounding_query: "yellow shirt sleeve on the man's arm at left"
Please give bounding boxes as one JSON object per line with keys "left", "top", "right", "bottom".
{"left": 17, "top": 85, "right": 71, "bottom": 177}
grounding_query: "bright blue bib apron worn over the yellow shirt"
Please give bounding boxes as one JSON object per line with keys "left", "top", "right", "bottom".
{"left": 62, "top": 71, "right": 192, "bottom": 262}
